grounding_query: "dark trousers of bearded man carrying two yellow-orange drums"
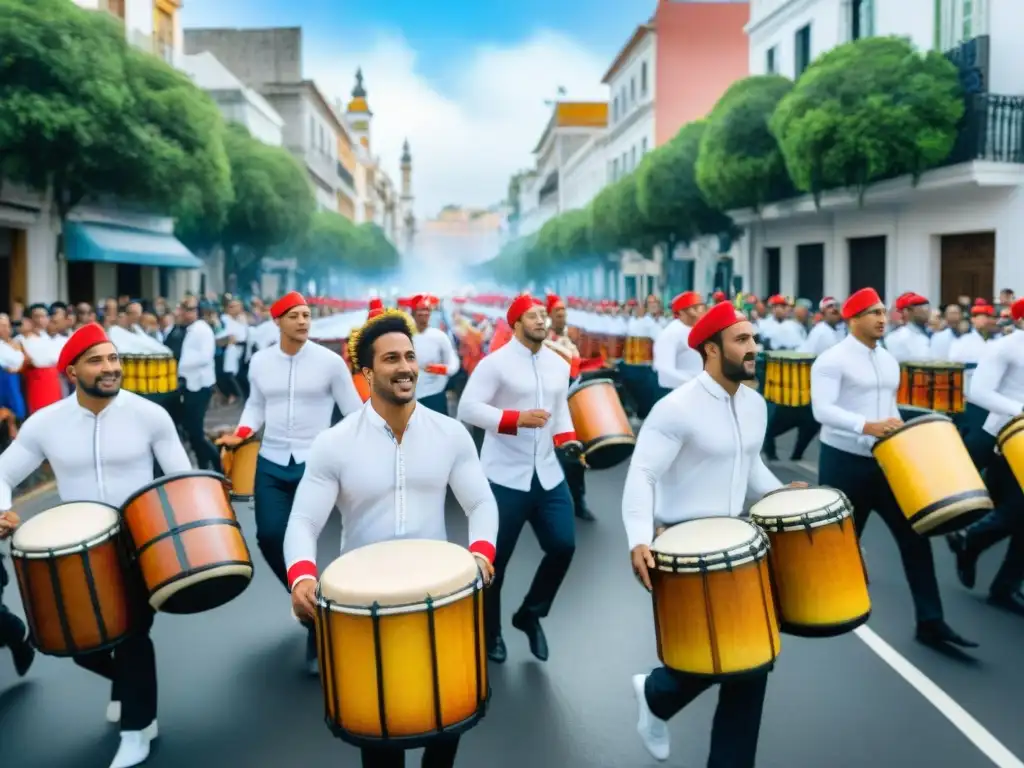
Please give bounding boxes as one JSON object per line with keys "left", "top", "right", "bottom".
{"left": 644, "top": 667, "right": 768, "bottom": 768}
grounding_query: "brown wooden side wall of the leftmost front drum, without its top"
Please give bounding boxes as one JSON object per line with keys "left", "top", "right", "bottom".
{"left": 11, "top": 526, "right": 143, "bottom": 656}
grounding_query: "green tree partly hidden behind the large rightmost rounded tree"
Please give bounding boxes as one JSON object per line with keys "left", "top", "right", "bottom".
{"left": 696, "top": 75, "right": 795, "bottom": 211}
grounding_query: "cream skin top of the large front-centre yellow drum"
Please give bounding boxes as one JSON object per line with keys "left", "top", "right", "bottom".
{"left": 319, "top": 539, "right": 479, "bottom": 607}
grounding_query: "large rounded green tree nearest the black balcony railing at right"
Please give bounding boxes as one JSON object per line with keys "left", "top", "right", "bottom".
{"left": 771, "top": 37, "right": 964, "bottom": 202}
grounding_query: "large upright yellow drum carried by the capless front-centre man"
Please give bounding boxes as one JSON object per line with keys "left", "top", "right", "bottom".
{"left": 316, "top": 539, "right": 488, "bottom": 749}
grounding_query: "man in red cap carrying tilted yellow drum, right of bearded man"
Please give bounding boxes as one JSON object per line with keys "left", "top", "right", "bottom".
{"left": 811, "top": 288, "right": 977, "bottom": 648}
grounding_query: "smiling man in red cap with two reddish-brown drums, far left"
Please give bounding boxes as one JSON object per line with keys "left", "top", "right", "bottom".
{"left": 0, "top": 324, "right": 191, "bottom": 768}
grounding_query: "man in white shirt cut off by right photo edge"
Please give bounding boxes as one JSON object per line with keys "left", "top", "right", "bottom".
{"left": 947, "top": 299, "right": 1024, "bottom": 615}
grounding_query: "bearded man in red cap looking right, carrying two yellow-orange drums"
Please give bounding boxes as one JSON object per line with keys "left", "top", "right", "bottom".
{"left": 623, "top": 303, "right": 786, "bottom": 768}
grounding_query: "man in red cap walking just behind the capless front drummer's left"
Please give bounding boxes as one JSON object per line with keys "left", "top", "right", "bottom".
{"left": 218, "top": 291, "right": 362, "bottom": 675}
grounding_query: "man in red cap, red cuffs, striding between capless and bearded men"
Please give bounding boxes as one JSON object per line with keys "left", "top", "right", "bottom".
{"left": 459, "top": 295, "right": 582, "bottom": 664}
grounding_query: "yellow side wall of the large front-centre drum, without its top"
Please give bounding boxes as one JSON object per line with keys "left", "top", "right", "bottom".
{"left": 316, "top": 586, "right": 488, "bottom": 749}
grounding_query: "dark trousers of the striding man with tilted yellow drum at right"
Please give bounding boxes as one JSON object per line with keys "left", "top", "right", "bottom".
{"left": 818, "top": 444, "right": 942, "bottom": 623}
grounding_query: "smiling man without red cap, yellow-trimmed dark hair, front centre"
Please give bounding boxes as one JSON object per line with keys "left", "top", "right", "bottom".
{"left": 285, "top": 310, "right": 498, "bottom": 768}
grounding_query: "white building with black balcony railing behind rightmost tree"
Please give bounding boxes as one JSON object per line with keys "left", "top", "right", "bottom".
{"left": 733, "top": 0, "right": 1024, "bottom": 303}
